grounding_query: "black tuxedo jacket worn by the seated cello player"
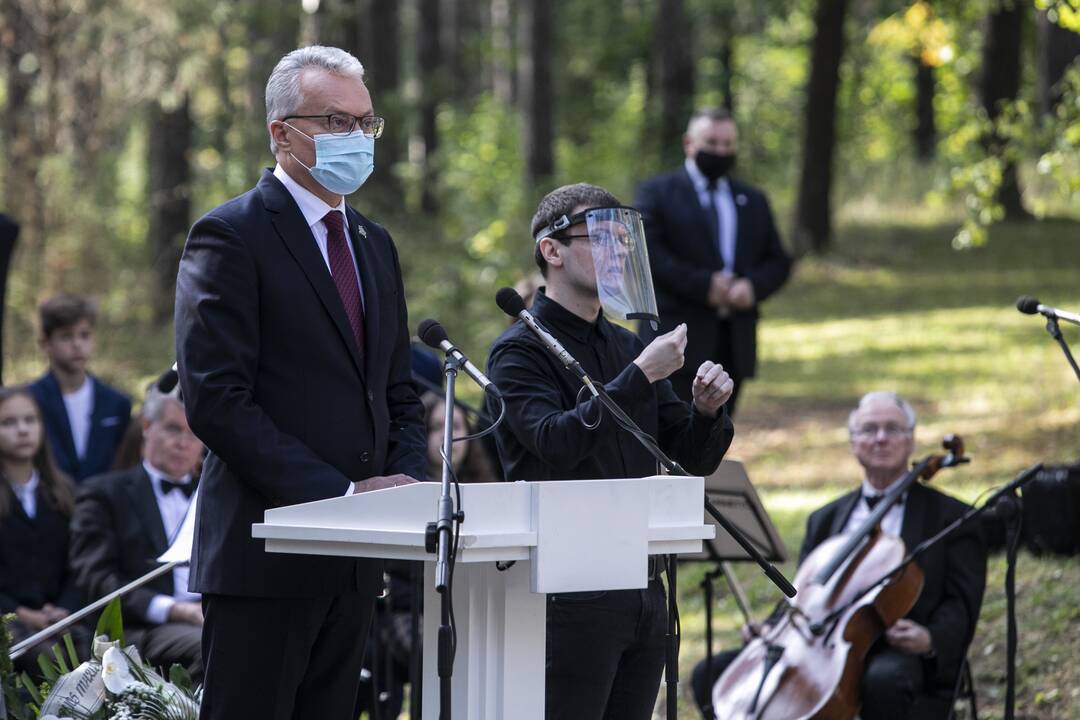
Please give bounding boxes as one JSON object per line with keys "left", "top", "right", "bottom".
{"left": 799, "top": 484, "right": 986, "bottom": 687}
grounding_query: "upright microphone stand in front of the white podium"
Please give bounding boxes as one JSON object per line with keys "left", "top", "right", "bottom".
{"left": 425, "top": 353, "right": 465, "bottom": 720}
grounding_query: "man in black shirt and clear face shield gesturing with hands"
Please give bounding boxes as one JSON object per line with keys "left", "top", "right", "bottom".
{"left": 488, "top": 184, "right": 734, "bottom": 720}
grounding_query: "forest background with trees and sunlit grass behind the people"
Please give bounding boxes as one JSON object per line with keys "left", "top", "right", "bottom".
{"left": 0, "top": 0, "right": 1080, "bottom": 718}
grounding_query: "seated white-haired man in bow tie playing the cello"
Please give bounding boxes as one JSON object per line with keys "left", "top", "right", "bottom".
{"left": 692, "top": 392, "right": 986, "bottom": 720}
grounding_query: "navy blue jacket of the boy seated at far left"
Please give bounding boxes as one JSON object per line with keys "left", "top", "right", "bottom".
{"left": 29, "top": 372, "right": 132, "bottom": 483}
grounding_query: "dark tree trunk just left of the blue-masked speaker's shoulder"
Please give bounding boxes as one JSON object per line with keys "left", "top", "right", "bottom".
{"left": 147, "top": 96, "right": 193, "bottom": 323}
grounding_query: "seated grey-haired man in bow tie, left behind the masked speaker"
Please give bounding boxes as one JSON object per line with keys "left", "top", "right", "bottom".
{"left": 70, "top": 384, "right": 203, "bottom": 681}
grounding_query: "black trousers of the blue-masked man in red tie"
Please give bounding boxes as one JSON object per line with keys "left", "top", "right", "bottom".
{"left": 199, "top": 593, "right": 375, "bottom": 720}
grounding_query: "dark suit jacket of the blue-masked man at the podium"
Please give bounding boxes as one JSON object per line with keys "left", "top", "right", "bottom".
{"left": 176, "top": 172, "right": 427, "bottom": 597}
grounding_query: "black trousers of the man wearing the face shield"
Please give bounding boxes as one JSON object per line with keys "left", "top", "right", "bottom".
{"left": 544, "top": 580, "right": 667, "bottom": 720}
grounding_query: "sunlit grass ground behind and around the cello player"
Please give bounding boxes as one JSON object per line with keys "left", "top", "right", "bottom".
{"left": 679, "top": 222, "right": 1080, "bottom": 720}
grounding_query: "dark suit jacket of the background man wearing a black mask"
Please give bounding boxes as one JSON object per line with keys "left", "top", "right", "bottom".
{"left": 634, "top": 167, "right": 791, "bottom": 379}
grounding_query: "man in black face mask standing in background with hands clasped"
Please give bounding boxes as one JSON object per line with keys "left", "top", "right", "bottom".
{"left": 634, "top": 108, "right": 791, "bottom": 413}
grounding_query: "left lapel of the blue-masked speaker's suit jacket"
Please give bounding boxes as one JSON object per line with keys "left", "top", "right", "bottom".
{"left": 259, "top": 171, "right": 366, "bottom": 378}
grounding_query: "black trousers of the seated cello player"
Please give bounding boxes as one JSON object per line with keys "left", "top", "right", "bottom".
{"left": 690, "top": 642, "right": 924, "bottom": 720}
